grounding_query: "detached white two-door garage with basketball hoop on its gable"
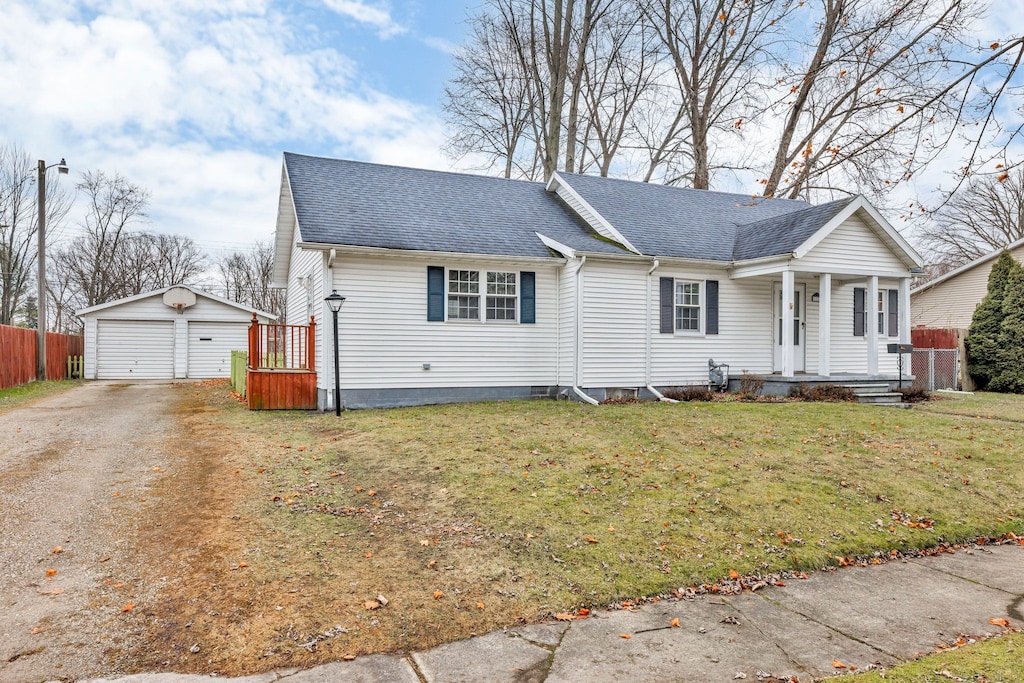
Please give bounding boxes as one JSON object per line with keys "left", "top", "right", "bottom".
{"left": 78, "top": 285, "right": 275, "bottom": 380}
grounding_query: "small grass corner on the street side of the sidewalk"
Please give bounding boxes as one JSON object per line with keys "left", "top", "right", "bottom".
{"left": 841, "top": 633, "right": 1024, "bottom": 683}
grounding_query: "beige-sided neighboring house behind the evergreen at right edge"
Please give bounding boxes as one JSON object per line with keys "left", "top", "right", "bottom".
{"left": 910, "top": 240, "right": 1024, "bottom": 330}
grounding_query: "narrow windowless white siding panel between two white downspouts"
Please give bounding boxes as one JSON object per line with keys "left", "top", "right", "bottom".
{"left": 580, "top": 259, "right": 650, "bottom": 388}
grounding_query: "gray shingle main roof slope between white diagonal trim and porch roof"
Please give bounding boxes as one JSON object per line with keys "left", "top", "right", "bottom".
{"left": 559, "top": 173, "right": 808, "bottom": 261}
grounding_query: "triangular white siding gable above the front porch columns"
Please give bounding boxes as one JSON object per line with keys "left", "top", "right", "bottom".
{"left": 797, "top": 216, "right": 907, "bottom": 272}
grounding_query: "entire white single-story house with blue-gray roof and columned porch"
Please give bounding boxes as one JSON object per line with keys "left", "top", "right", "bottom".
{"left": 274, "top": 154, "right": 922, "bottom": 408}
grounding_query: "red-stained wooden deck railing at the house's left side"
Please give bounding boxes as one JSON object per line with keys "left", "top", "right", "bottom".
{"left": 246, "top": 314, "right": 316, "bottom": 411}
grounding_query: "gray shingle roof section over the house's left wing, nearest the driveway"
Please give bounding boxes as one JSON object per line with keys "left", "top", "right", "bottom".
{"left": 285, "top": 153, "right": 623, "bottom": 256}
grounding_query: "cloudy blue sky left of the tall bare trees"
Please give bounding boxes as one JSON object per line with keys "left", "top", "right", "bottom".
{"left": 0, "top": 0, "right": 473, "bottom": 255}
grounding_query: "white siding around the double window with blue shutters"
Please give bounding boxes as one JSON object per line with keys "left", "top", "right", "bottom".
{"left": 326, "top": 256, "right": 557, "bottom": 389}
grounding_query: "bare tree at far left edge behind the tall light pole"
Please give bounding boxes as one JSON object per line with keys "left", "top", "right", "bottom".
{"left": 0, "top": 143, "right": 71, "bottom": 325}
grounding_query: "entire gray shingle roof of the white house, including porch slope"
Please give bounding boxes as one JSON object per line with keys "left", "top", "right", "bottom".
{"left": 285, "top": 153, "right": 864, "bottom": 262}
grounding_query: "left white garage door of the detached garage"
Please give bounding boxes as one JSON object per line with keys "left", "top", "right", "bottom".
{"left": 96, "top": 321, "right": 174, "bottom": 380}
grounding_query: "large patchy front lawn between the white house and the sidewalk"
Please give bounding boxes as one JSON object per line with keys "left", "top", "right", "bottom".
{"left": 130, "top": 386, "right": 1024, "bottom": 674}
